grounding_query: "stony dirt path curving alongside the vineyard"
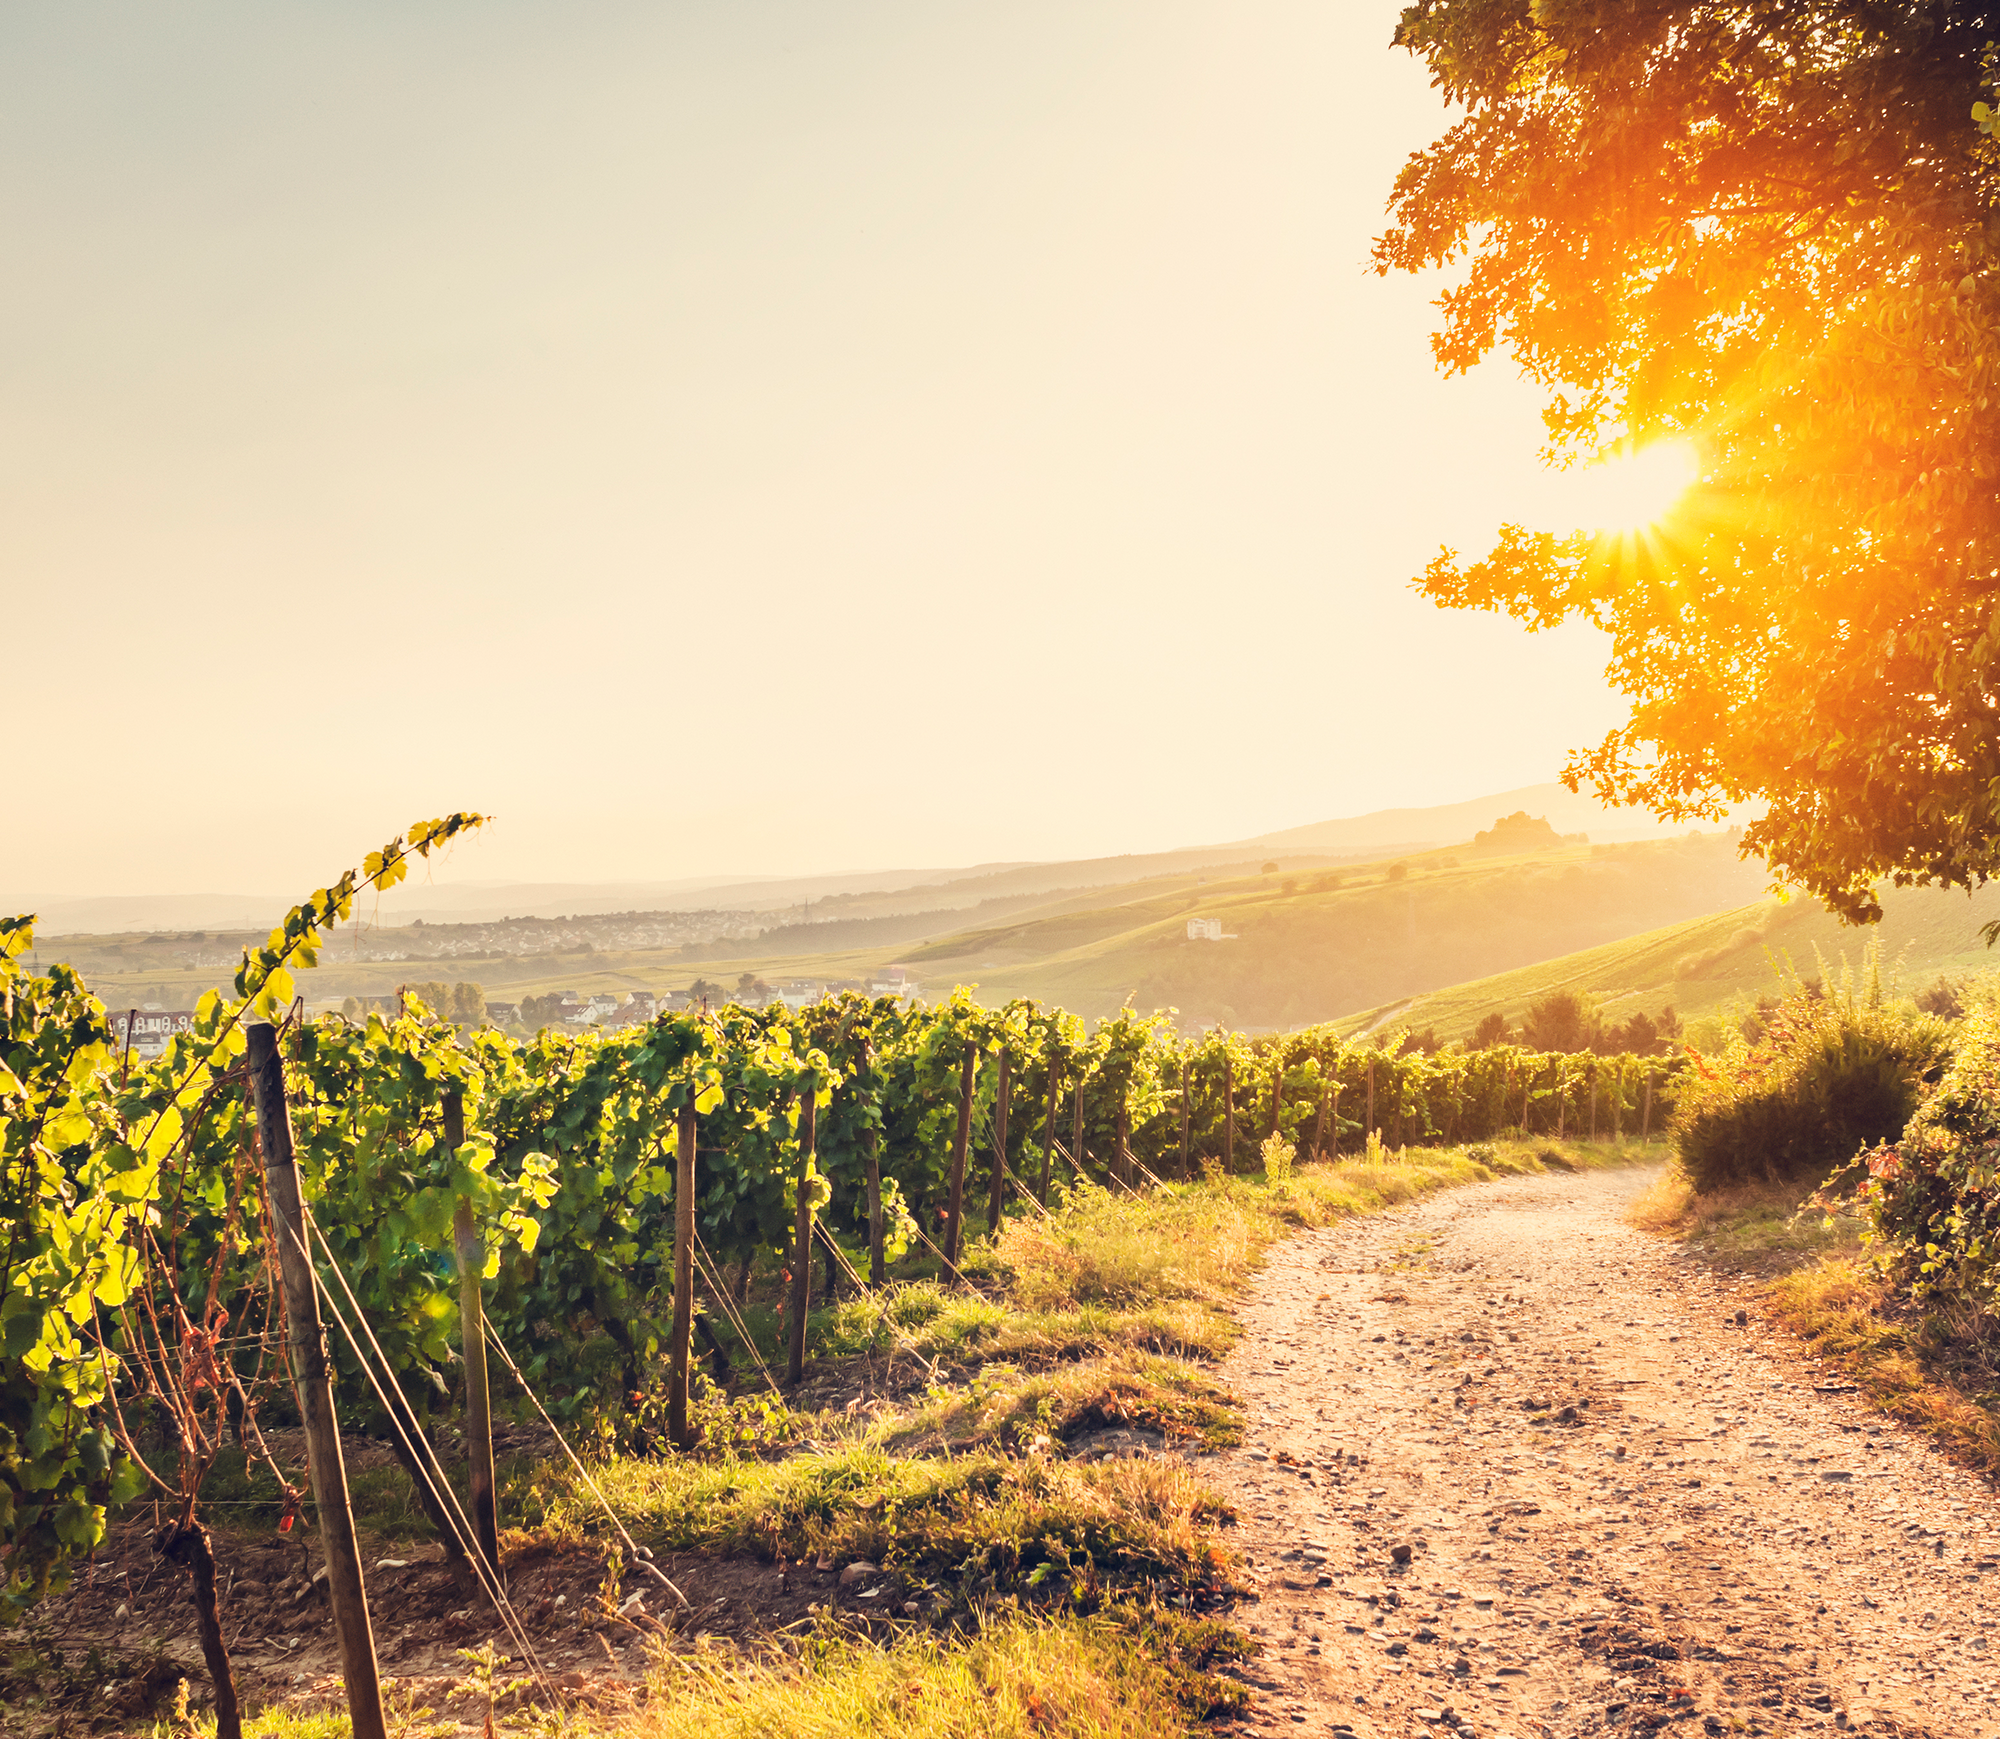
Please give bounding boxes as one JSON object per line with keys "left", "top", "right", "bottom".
{"left": 1204, "top": 1169, "right": 2000, "bottom": 1739}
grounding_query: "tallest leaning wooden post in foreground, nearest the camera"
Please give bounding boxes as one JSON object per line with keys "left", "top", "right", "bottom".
{"left": 246, "top": 1025, "right": 388, "bottom": 1739}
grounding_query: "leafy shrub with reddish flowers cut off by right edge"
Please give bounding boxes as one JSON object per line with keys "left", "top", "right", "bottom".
{"left": 1828, "top": 1005, "right": 2000, "bottom": 1309}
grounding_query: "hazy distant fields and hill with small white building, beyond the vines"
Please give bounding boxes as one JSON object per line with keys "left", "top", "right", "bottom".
{"left": 38, "top": 836, "right": 1762, "bottom": 1029}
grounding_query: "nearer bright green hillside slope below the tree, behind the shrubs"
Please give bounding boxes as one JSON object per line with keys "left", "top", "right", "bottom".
{"left": 1354, "top": 887, "right": 2000, "bottom": 1039}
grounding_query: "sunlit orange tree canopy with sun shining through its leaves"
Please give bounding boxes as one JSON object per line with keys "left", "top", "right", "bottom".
{"left": 1376, "top": 0, "right": 2000, "bottom": 919}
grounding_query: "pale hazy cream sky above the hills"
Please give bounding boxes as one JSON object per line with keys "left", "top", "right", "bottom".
{"left": 0, "top": 0, "right": 1618, "bottom": 909}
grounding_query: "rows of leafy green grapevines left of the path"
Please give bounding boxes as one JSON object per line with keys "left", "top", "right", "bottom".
{"left": 0, "top": 814, "right": 1672, "bottom": 1739}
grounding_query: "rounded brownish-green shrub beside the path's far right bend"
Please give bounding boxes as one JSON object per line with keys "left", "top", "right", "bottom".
{"left": 1670, "top": 987, "right": 1950, "bottom": 1195}
